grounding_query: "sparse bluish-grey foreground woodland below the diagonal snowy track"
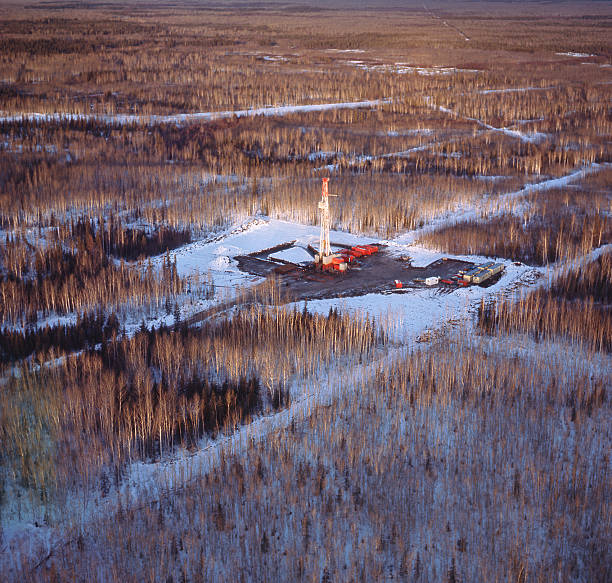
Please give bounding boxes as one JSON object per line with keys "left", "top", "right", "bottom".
{"left": 14, "top": 340, "right": 610, "bottom": 583}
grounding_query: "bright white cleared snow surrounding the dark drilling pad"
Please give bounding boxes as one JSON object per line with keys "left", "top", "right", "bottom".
{"left": 137, "top": 212, "right": 540, "bottom": 341}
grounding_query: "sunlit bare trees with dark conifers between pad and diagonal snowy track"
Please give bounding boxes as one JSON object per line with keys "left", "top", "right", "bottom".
{"left": 0, "top": 308, "right": 384, "bottom": 516}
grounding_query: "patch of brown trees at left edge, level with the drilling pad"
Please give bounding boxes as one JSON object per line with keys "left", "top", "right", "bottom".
{"left": 0, "top": 223, "right": 185, "bottom": 325}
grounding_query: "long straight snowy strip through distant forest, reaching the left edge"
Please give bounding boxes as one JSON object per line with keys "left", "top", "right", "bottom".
{"left": 0, "top": 99, "right": 391, "bottom": 125}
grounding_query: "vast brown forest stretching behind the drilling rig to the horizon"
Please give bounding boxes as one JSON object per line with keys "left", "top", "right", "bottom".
{"left": 0, "top": 1, "right": 611, "bottom": 242}
